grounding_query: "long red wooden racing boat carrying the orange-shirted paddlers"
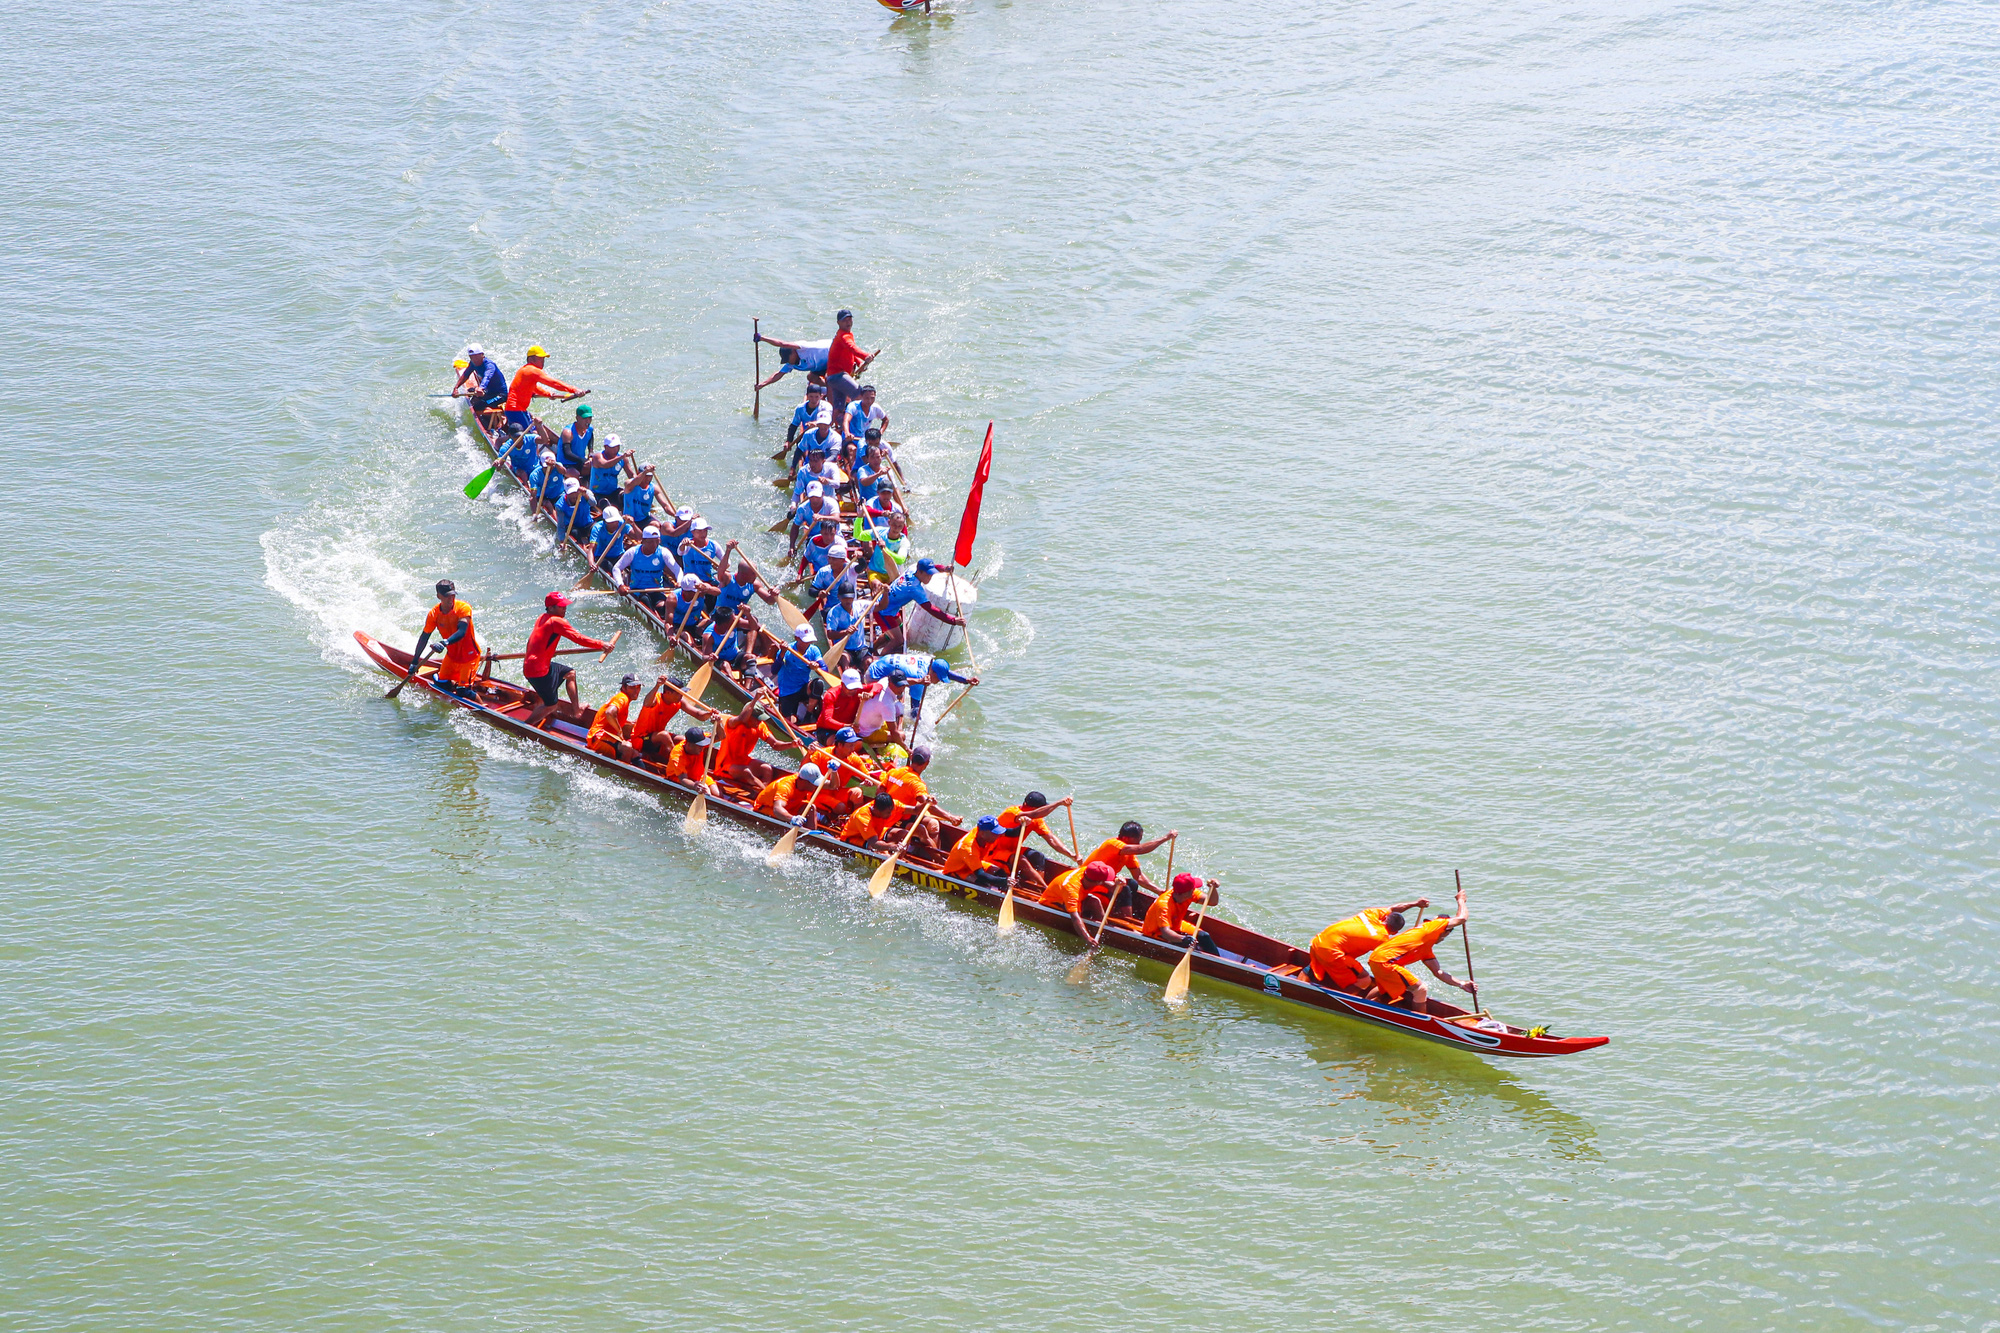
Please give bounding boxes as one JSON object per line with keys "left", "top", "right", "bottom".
{"left": 354, "top": 630, "right": 1610, "bottom": 1059}
